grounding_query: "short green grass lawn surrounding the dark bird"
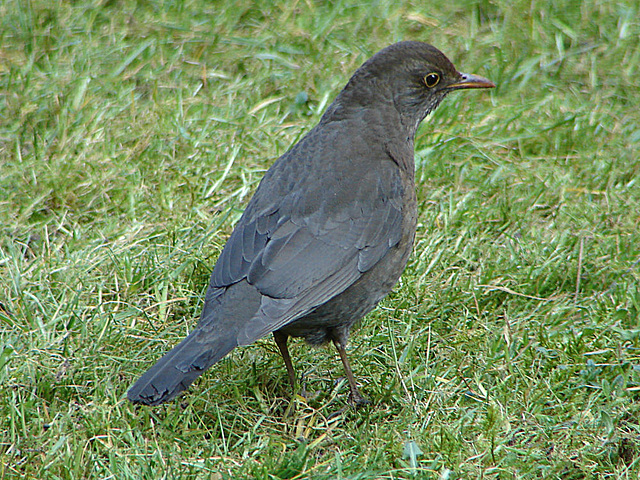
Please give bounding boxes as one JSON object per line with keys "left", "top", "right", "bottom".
{"left": 0, "top": 0, "right": 640, "bottom": 480}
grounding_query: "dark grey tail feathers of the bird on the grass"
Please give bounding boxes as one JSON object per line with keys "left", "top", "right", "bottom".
{"left": 127, "top": 328, "right": 237, "bottom": 405}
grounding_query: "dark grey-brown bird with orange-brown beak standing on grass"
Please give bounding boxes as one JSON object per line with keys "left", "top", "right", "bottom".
{"left": 127, "top": 41, "right": 495, "bottom": 406}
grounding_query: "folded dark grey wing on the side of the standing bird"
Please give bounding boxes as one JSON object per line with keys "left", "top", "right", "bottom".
{"left": 211, "top": 163, "right": 402, "bottom": 344}
